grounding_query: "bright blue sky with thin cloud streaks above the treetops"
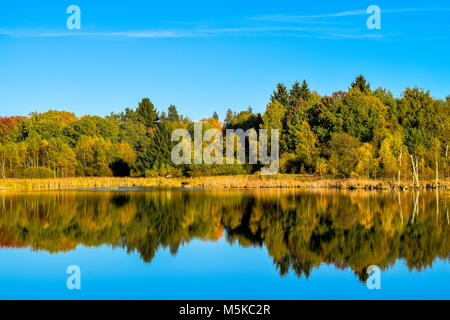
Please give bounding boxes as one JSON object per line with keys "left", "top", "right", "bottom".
{"left": 0, "top": 0, "right": 450, "bottom": 120}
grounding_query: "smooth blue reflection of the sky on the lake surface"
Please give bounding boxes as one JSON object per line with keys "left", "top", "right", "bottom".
{"left": 0, "top": 238, "right": 450, "bottom": 299}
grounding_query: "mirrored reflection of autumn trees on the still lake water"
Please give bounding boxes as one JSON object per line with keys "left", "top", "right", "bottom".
{"left": 0, "top": 191, "right": 449, "bottom": 280}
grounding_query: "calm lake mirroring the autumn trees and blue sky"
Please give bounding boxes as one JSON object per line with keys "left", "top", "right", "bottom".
{"left": 0, "top": 189, "right": 450, "bottom": 299}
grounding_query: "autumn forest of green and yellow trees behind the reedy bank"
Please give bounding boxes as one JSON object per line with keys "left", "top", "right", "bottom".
{"left": 0, "top": 75, "right": 450, "bottom": 184}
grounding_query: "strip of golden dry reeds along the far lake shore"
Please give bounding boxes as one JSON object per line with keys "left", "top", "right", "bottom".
{"left": 0, "top": 174, "right": 450, "bottom": 191}
